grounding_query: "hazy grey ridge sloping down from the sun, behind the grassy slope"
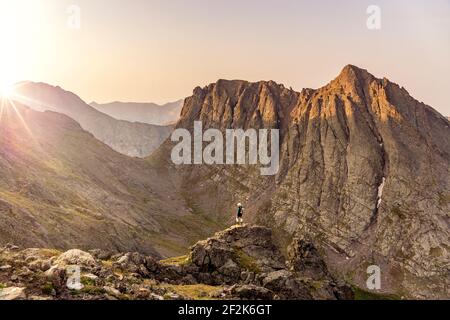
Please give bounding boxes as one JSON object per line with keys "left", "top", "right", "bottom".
{"left": 14, "top": 82, "right": 173, "bottom": 158}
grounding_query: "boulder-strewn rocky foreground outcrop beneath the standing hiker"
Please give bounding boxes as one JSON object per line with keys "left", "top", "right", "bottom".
{"left": 0, "top": 226, "right": 357, "bottom": 300}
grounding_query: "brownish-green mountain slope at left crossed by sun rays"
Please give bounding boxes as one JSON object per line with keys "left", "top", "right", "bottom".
{"left": 0, "top": 101, "right": 220, "bottom": 256}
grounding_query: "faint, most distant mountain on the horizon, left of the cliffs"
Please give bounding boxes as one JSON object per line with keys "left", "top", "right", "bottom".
{"left": 90, "top": 100, "right": 183, "bottom": 126}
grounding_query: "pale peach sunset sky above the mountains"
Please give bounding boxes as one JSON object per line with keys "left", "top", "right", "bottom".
{"left": 0, "top": 0, "right": 450, "bottom": 116}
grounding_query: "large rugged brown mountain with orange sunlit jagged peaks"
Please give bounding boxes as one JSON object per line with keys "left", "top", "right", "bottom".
{"left": 148, "top": 65, "right": 450, "bottom": 298}
